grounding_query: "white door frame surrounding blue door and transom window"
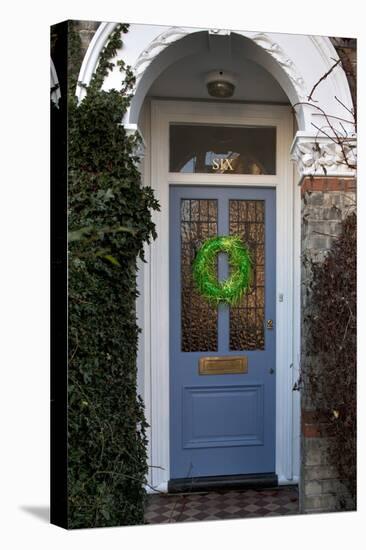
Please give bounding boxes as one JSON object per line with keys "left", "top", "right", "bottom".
{"left": 143, "top": 100, "right": 300, "bottom": 491}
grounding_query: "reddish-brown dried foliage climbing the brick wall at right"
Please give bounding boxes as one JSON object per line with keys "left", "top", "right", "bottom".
{"left": 303, "top": 212, "right": 356, "bottom": 508}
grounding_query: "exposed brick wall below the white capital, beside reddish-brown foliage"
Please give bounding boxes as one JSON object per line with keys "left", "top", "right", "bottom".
{"left": 300, "top": 177, "right": 356, "bottom": 513}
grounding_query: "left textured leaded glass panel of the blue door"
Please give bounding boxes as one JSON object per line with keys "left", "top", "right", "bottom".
{"left": 180, "top": 199, "right": 217, "bottom": 351}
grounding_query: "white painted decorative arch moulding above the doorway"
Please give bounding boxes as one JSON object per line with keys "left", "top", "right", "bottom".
{"left": 77, "top": 23, "right": 352, "bottom": 140}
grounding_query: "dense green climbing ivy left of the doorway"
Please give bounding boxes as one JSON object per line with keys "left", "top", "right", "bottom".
{"left": 61, "top": 24, "right": 159, "bottom": 528}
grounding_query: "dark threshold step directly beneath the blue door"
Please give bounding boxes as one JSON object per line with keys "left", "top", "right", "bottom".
{"left": 168, "top": 473, "right": 278, "bottom": 493}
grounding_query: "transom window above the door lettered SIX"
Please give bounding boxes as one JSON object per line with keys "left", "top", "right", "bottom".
{"left": 170, "top": 124, "right": 276, "bottom": 174}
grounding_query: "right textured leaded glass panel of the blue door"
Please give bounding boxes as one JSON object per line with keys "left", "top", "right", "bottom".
{"left": 229, "top": 200, "right": 265, "bottom": 351}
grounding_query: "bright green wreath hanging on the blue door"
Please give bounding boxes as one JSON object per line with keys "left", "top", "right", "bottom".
{"left": 192, "top": 235, "right": 252, "bottom": 305}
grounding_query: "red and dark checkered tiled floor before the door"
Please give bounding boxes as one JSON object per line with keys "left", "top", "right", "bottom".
{"left": 145, "top": 486, "right": 299, "bottom": 523}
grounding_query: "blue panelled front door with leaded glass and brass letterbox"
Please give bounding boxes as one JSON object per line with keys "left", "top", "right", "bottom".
{"left": 169, "top": 186, "right": 276, "bottom": 479}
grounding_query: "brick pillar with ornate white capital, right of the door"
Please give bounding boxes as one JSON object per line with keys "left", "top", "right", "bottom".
{"left": 291, "top": 132, "right": 356, "bottom": 513}
